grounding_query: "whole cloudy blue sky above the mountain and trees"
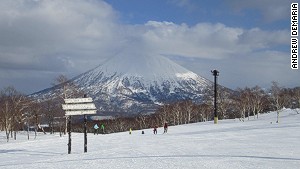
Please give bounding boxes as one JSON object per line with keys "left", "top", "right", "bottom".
{"left": 0, "top": 0, "right": 300, "bottom": 93}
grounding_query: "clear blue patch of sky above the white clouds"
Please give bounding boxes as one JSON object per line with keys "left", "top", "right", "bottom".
{"left": 106, "top": 0, "right": 292, "bottom": 30}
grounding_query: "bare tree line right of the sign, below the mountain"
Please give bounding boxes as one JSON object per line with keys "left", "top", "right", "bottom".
{"left": 90, "top": 82, "right": 300, "bottom": 133}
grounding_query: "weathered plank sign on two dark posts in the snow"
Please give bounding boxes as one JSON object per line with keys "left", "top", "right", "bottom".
{"left": 62, "top": 97, "right": 97, "bottom": 154}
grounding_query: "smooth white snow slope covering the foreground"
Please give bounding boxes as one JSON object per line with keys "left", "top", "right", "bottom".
{"left": 0, "top": 109, "right": 300, "bottom": 169}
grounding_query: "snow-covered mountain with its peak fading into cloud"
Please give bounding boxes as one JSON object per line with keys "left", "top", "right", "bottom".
{"left": 34, "top": 55, "right": 212, "bottom": 113}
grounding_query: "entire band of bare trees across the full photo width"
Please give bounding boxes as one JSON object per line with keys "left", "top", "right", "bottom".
{"left": 0, "top": 78, "right": 300, "bottom": 141}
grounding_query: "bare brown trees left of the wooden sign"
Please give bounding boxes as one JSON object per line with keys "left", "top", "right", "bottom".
{"left": 0, "top": 75, "right": 83, "bottom": 141}
